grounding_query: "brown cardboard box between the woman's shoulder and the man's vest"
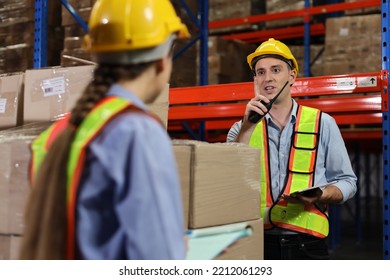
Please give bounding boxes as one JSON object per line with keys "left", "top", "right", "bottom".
{"left": 173, "top": 140, "right": 260, "bottom": 229}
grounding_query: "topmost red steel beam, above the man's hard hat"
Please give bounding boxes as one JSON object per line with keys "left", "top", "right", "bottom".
{"left": 208, "top": 0, "right": 381, "bottom": 29}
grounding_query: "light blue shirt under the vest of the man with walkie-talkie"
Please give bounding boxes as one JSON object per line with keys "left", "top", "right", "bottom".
{"left": 227, "top": 100, "right": 357, "bottom": 203}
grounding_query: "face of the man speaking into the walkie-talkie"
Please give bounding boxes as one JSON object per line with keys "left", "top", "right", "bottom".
{"left": 254, "top": 57, "right": 296, "bottom": 99}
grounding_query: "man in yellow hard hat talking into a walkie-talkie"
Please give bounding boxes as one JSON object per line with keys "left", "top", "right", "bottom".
{"left": 227, "top": 38, "right": 357, "bottom": 259}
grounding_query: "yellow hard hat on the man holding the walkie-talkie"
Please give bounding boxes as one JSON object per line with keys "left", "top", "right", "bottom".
{"left": 247, "top": 38, "right": 299, "bottom": 73}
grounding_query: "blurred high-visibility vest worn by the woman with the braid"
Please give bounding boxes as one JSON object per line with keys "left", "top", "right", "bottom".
{"left": 31, "top": 97, "right": 155, "bottom": 259}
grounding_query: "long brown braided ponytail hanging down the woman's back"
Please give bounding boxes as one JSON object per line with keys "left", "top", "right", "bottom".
{"left": 20, "top": 63, "right": 151, "bottom": 260}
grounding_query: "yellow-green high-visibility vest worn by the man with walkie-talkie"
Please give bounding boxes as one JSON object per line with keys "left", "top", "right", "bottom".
{"left": 249, "top": 106, "right": 329, "bottom": 238}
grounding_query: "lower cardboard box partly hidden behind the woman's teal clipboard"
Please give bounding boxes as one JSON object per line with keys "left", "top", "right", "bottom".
{"left": 215, "top": 218, "right": 264, "bottom": 260}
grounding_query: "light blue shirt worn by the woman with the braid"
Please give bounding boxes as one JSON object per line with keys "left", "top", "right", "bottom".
{"left": 76, "top": 85, "right": 185, "bottom": 260}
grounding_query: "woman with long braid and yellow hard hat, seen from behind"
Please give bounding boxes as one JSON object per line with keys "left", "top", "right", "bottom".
{"left": 20, "top": 0, "right": 189, "bottom": 259}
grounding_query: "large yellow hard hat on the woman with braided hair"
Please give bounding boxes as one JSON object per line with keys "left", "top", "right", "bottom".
{"left": 84, "top": 0, "right": 189, "bottom": 53}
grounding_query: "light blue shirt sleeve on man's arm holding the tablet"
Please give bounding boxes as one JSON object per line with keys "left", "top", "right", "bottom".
{"left": 321, "top": 113, "right": 357, "bottom": 203}
